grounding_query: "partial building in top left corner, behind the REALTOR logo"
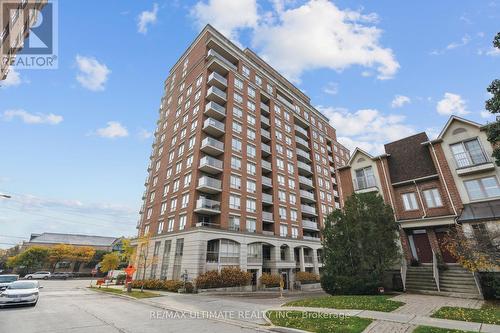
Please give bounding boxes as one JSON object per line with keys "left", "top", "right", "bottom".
{"left": 0, "top": 0, "right": 47, "bottom": 81}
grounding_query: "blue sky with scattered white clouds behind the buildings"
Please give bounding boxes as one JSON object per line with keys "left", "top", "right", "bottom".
{"left": 0, "top": 0, "right": 500, "bottom": 247}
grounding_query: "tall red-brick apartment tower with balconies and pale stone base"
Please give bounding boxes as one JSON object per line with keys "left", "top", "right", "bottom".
{"left": 137, "top": 26, "right": 349, "bottom": 284}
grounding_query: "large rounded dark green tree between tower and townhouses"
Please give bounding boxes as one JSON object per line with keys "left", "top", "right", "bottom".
{"left": 321, "top": 193, "right": 400, "bottom": 294}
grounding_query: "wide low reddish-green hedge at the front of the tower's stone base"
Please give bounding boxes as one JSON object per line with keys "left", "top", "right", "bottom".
{"left": 195, "top": 267, "right": 252, "bottom": 289}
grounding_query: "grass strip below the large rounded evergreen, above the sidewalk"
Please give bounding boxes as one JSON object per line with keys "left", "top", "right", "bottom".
{"left": 285, "top": 295, "right": 404, "bottom": 312}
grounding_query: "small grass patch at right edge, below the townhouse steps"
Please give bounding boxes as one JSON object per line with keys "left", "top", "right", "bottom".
{"left": 432, "top": 303, "right": 500, "bottom": 325}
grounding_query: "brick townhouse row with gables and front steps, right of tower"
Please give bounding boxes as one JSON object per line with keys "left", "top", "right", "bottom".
{"left": 339, "top": 116, "right": 500, "bottom": 296}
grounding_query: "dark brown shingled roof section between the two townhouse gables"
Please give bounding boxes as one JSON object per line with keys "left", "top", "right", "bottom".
{"left": 385, "top": 132, "right": 437, "bottom": 183}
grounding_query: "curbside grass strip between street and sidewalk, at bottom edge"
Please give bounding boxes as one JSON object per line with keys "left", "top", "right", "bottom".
{"left": 266, "top": 311, "right": 372, "bottom": 333}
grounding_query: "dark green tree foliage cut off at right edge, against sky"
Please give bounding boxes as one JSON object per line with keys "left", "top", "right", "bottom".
{"left": 485, "top": 32, "right": 500, "bottom": 166}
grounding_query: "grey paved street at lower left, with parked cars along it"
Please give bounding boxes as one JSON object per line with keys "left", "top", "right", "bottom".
{"left": 0, "top": 280, "right": 265, "bottom": 333}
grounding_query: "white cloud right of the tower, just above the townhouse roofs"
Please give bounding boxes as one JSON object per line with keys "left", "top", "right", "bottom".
{"left": 318, "top": 106, "right": 415, "bottom": 154}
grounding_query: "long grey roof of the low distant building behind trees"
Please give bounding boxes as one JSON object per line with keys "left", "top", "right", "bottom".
{"left": 29, "top": 232, "right": 120, "bottom": 246}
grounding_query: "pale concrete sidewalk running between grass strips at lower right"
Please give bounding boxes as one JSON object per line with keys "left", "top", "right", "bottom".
{"left": 269, "top": 306, "right": 500, "bottom": 333}
